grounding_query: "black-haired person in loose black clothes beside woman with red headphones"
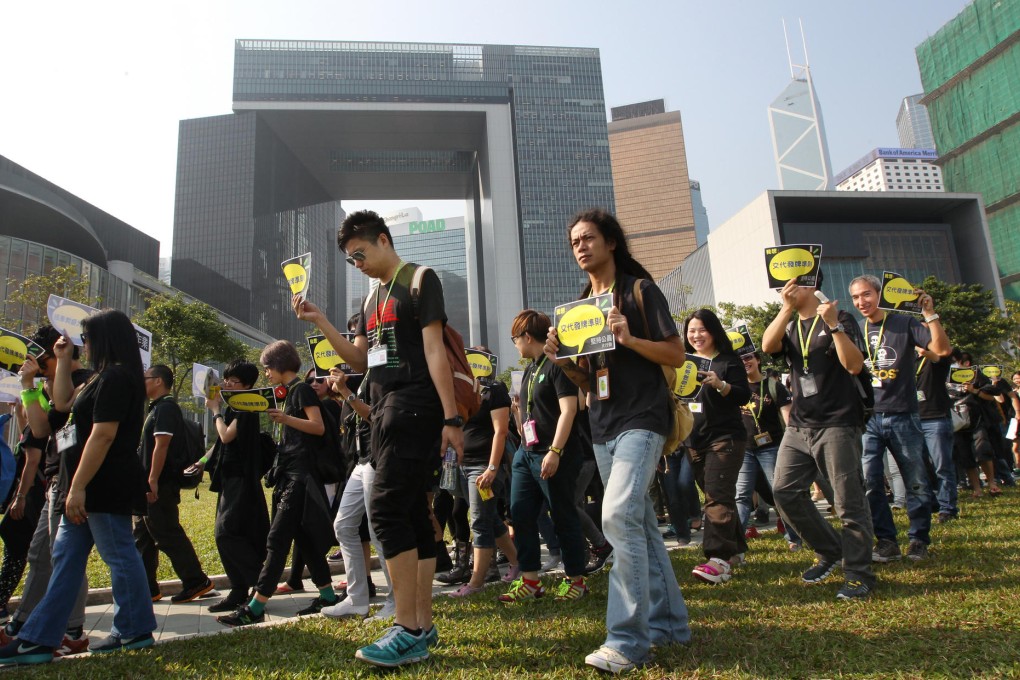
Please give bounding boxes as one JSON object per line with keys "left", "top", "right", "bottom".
{"left": 199, "top": 359, "right": 269, "bottom": 613}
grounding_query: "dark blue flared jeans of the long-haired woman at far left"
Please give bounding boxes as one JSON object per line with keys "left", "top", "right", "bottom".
{"left": 18, "top": 513, "right": 156, "bottom": 647}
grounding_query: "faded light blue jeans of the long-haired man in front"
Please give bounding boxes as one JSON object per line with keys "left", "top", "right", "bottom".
{"left": 595, "top": 430, "right": 691, "bottom": 663}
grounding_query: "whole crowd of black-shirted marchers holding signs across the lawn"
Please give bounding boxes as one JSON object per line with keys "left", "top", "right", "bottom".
{"left": 0, "top": 210, "right": 1020, "bottom": 674}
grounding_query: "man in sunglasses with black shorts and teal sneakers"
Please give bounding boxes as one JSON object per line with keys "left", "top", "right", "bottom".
{"left": 294, "top": 210, "right": 464, "bottom": 667}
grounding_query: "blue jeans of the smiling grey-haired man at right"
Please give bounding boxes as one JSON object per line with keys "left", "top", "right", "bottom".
{"left": 861, "top": 413, "right": 933, "bottom": 545}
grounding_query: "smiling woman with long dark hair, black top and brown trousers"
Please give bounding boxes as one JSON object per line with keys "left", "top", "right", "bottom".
{"left": 683, "top": 309, "right": 751, "bottom": 583}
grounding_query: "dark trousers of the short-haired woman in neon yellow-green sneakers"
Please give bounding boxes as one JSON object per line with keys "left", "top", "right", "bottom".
{"left": 510, "top": 448, "right": 588, "bottom": 576}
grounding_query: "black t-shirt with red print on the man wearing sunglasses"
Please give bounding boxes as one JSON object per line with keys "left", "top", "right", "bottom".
{"left": 355, "top": 262, "right": 447, "bottom": 411}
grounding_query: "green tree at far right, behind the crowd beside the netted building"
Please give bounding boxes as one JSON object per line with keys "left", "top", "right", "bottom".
{"left": 921, "top": 276, "right": 1020, "bottom": 361}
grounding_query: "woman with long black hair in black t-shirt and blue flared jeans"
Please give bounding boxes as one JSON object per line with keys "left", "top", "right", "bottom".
{"left": 0, "top": 310, "right": 156, "bottom": 664}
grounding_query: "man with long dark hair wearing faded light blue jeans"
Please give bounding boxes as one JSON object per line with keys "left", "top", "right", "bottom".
{"left": 545, "top": 209, "right": 691, "bottom": 673}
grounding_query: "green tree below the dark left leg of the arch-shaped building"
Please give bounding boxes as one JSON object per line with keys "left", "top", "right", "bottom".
{"left": 135, "top": 293, "right": 248, "bottom": 398}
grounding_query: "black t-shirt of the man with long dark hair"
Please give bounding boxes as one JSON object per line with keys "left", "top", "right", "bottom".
{"left": 588, "top": 273, "right": 678, "bottom": 443}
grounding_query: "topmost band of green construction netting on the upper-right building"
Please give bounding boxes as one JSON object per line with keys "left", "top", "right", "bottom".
{"left": 917, "top": 0, "right": 1020, "bottom": 92}
